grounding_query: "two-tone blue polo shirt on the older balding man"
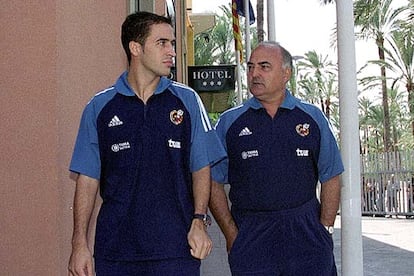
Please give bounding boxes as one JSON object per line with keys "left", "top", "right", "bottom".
{"left": 212, "top": 90, "right": 344, "bottom": 211}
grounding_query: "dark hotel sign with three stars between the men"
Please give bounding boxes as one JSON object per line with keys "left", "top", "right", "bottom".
{"left": 188, "top": 65, "right": 236, "bottom": 92}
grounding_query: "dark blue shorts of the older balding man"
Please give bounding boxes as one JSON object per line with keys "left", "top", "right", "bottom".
{"left": 229, "top": 199, "right": 337, "bottom": 276}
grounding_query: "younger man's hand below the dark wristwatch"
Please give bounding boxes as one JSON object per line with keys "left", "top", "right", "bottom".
{"left": 187, "top": 219, "right": 213, "bottom": 260}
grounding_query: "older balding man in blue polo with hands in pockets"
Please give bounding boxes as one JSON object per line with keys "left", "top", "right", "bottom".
{"left": 210, "top": 42, "right": 343, "bottom": 276}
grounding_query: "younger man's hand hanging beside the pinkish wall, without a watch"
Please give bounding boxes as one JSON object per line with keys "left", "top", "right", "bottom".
{"left": 68, "top": 247, "right": 94, "bottom": 276}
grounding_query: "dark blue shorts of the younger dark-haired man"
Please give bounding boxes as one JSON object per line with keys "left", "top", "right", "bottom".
{"left": 95, "top": 258, "right": 200, "bottom": 276}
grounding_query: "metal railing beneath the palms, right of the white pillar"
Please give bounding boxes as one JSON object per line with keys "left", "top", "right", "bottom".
{"left": 361, "top": 151, "right": 414, "bottom": 218}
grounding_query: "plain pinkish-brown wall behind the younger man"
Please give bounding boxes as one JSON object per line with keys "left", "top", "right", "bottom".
{"left": 0, "top": 0, "right": 127, "bottom": 275}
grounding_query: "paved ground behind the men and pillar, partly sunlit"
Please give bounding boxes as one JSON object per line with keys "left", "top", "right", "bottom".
{"left": 201, "top": 216, "right": 414, "bottom": 276}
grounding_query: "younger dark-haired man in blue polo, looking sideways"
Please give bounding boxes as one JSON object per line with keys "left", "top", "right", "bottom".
{"left": 69, "top": 12, "right": 225, "bottom": 276}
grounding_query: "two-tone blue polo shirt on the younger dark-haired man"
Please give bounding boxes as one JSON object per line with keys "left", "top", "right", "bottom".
{"left": 70, "top": 72, "right": 225, "bottom": 261}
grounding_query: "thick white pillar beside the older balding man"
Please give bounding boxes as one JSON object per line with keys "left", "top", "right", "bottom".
{"left": 336, "top": 0, "right": 363, "bottom": 276}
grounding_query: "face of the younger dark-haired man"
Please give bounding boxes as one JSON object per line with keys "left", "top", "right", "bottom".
{"left": 139, "top": 24, "right": 176, "bottom": 76}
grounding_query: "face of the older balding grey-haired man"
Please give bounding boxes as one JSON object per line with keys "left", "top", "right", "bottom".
{"left": 247, "top": 45, "right": 290, "bottom": 100}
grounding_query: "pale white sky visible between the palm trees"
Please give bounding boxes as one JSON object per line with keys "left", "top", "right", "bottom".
{"left": 192, "top": 0, "right": 403, "bottom": 70}
